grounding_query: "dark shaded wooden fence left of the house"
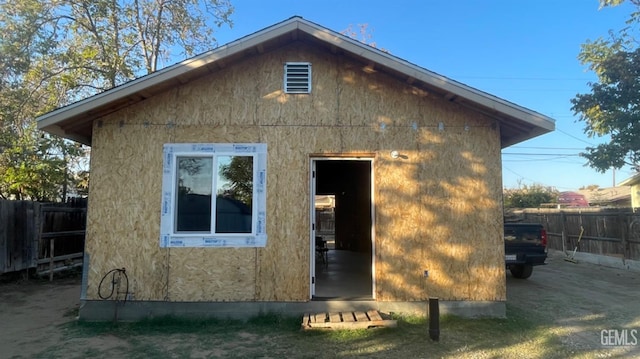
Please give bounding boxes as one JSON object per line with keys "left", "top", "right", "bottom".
{"left": 0, "top": 200, "right": 86, "bottom": 277}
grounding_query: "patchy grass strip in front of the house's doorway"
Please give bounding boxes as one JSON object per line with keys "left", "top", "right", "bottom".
{"left": 40, "top": 306, "right": 608, "bottom": 358}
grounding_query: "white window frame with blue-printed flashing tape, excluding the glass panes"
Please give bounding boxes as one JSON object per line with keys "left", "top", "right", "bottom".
{"left": 160, "top": 143, "right": 267, "bottom": 248}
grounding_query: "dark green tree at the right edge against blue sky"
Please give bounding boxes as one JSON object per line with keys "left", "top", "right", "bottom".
{"left": 571, "top": 0, "right": 640, "bottom": 172}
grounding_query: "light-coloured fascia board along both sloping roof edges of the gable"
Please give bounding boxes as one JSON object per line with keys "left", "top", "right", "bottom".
{"left": 37, "top": 17, "right": 555, "bottom": 136}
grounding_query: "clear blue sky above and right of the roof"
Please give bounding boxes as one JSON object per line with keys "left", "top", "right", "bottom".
{"left": 202, "top": 0, "right": 634, "bottom": 191}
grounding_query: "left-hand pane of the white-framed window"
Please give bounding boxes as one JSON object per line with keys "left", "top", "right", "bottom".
{"left": 176, "top": 157, "right": 213, "bottom": 232}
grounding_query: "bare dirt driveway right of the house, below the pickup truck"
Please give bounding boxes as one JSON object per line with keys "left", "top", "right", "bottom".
{"left": 507, "top": 251, "right": 640, "bottom": 358}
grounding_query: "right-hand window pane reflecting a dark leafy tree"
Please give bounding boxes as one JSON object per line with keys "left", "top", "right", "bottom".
{"left": 215, "top": 156, "right": 253, "bottom": 233}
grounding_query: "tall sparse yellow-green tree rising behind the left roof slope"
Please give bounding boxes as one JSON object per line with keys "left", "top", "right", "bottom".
{"left": 0, "top": 0, "right": 233, "bottom": 90}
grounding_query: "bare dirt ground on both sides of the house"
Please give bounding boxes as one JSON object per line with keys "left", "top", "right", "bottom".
{"left": 0, "top": 253, "right": 640, "bottom": 358}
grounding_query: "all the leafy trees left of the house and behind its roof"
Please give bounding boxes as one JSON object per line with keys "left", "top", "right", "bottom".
{"left": 0, "top": 0, "right": 233, "bottom": 200}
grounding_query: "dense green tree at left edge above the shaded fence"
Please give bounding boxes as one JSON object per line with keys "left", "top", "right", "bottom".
{"left": 0, "top": 1, "right": 83, "bottom": 201}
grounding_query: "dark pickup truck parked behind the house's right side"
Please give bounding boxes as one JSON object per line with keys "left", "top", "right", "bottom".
{"left": 504, "top": 222, "right": 547, "bottom": 279}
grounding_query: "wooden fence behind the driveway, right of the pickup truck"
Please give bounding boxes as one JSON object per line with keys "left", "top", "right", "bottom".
{"left": 512, "top": 208, "right": 640, "bottom": 260}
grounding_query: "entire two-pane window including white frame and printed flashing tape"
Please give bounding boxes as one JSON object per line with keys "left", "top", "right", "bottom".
{"left": 160, "top": 143, "right": 267, "bottom": 248}
